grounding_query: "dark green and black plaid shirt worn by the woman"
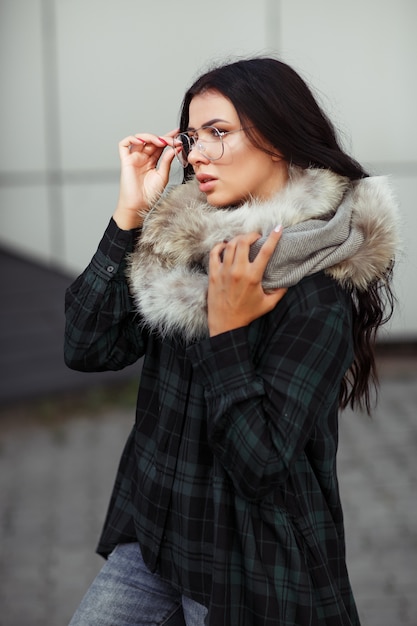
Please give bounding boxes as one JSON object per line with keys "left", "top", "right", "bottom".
{"left": 65, "top": 221, "right": 359, "bottom": 626}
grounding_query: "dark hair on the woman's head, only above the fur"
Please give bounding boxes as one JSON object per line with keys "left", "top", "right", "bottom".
{"left": 180, "top": 58, "right": 367, "bottom": 180}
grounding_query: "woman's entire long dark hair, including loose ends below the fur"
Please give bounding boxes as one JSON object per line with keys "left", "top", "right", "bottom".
{"left": 180, "top": 57, "right": 394, "bottom": 413}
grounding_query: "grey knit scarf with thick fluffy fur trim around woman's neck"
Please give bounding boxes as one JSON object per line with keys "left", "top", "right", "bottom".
{"left": 128, "top": 168, "right": 398, "bottom": 341}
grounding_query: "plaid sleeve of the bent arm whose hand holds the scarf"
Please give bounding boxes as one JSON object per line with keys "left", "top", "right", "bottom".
{"left": 190, "top": 278, "right": 352, "bottom": 500}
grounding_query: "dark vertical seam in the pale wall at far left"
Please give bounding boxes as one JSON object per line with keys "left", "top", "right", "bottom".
{"left": 40, "top": 0, "right": 65, "bottom": 264}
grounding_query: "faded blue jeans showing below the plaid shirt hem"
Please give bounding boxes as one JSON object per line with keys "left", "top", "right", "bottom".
{"left": 69, "top": 543, "right": 208, "bottom": 626}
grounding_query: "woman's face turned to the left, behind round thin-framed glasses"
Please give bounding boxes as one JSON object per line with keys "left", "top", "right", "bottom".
{"left": 187, "top": 91, "right": 288, "bottom": 207}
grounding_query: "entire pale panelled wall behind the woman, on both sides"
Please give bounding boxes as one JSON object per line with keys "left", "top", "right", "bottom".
{"left": 0, "top": 0, "right": 417, "bottom": 337}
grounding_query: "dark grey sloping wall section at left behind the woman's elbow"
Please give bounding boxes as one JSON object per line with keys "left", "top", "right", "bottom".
{"left": 0, "top": 248, "right": 141, "bottom": 404}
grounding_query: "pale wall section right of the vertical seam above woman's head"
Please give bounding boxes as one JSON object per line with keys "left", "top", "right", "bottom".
{"left": 279, "top": 0, "right": 417, "bottom": 339}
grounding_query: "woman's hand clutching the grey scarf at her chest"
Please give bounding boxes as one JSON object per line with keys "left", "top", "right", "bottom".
{"left": 207, "top": 228, "right": 287, "bottom": 337}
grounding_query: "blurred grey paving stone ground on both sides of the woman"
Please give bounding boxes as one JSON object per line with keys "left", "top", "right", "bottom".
{"left": 0, "top": 360, "right": 417, "bottom": 626}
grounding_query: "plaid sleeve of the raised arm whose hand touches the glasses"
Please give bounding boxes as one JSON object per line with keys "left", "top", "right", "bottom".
{"left": 64, "top": 219, "right": 145, "bottom": 372}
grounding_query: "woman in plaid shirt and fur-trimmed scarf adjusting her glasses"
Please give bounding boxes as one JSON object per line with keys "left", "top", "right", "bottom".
{"left": 65, "top": 58, "right": 397, "bottom": 626}
